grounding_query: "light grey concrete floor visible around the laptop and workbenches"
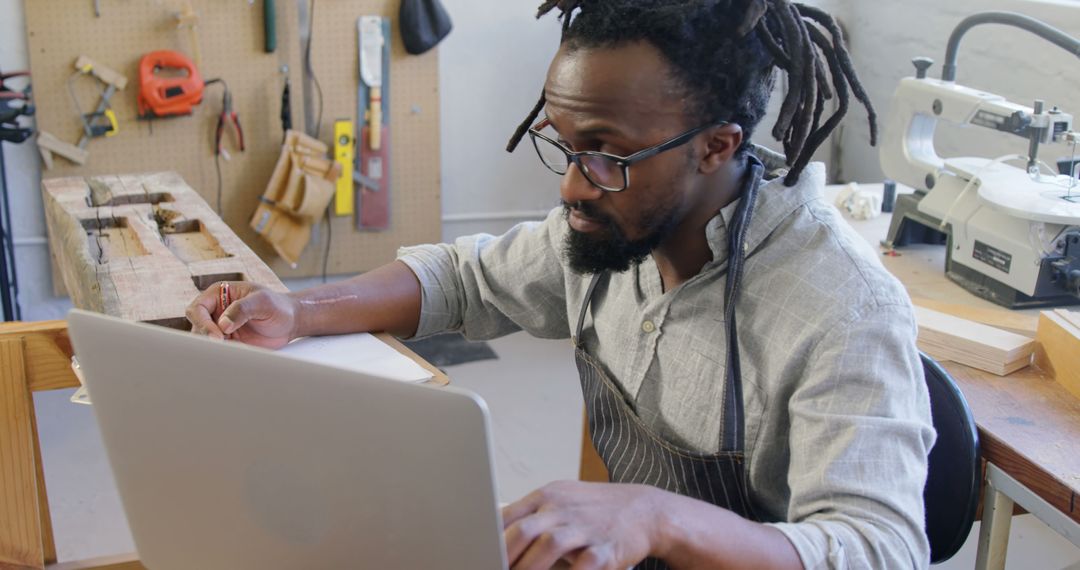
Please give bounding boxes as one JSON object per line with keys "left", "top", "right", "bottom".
{"left": 29, "top": 334, "right": 1080, "bottom": 570}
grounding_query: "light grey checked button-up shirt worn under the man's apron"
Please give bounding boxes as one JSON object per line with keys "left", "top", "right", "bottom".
{"left": 399, "top": 163, "right": 934, "bottom": 569}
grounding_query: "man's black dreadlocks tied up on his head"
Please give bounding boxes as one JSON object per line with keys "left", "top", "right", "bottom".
{"left": 507, "top": 0, "right": 877, "bottom": 186}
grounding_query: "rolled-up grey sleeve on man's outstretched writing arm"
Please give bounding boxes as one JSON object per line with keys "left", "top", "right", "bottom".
{"left": 397, "top": 208, "right": 570, "bottom": 340}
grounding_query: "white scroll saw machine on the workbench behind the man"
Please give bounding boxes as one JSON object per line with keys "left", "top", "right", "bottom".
{"left": 880, "top": 12, "right": 1080, "bottom": 309}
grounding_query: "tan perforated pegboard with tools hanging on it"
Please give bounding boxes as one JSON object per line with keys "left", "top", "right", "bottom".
{"left": 24, "top": 0, "right": 442, "bottom": 277}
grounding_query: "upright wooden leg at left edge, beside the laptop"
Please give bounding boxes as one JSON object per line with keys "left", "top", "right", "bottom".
{"left": 0, "top": 339, "right": 45, "bottom": 568}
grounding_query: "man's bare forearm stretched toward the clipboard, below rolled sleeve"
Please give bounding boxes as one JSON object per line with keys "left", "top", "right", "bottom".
{"left": 289, "top": 261, "right": 420, "bottom": 337}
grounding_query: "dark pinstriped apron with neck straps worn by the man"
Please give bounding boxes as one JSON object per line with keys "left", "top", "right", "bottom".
{"left": 573, "top": 157, "right": 764, "bottom": 570}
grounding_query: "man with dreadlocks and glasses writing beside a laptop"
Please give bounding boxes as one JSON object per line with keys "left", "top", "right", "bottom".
{"left": 188, "top": 0, "right": 934, "bottom": 570}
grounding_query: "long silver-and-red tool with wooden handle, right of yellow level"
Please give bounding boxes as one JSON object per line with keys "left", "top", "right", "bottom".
{"left": 354, "top": 16, "right": 390, "bottom": 230}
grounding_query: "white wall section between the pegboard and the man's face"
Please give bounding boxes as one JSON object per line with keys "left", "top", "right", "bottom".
{"left": 438, "top": 0, "right": 559, "bottom": 240}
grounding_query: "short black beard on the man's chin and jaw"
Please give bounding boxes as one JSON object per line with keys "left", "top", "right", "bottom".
{"left": 563, "top": 202, "right": 676, "bottom": 273}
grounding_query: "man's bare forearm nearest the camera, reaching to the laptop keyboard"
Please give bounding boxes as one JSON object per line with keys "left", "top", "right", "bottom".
{"left": 654, "top": 491, "right": 802, "bottom": 570}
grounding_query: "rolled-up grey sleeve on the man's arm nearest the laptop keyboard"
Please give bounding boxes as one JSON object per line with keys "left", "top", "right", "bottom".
{"left": 772, "top": 304, "right": 935, "bottom": 569}
